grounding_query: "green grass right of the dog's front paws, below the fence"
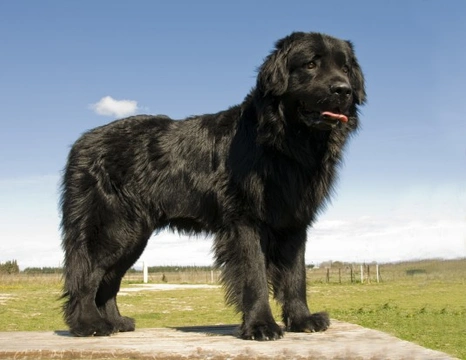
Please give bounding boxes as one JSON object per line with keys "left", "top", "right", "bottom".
{"left": 309, "top": 281, "right": 466, "bottom": 359}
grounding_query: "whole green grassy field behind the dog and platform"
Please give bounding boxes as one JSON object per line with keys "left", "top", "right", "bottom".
{"left": 0, "top": 259, "right": 466, "bottom": 359}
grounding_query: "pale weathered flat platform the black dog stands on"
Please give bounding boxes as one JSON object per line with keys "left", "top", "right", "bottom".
{"left": 0, "top": 320, "right": 454, "bottom": 360}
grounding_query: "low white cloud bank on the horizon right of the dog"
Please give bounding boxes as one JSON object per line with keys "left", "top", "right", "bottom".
{"left": 306, "top": 215, "right": 466, "bottom": 263}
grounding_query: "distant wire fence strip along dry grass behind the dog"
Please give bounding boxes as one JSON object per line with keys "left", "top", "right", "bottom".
{"left": 0, "top": 258, "right": 466, "bottom": 284}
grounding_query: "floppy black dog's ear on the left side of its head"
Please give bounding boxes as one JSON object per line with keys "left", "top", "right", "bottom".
{"left": 257, "top": 33, "right": 296, "bottom": 96}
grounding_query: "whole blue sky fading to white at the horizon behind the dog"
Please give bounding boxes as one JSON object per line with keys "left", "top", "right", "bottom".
{"left": 0, "top": 0, "right": 466, "bottom": 268}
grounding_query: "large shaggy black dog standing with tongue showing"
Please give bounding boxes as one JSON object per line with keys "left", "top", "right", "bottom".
{"left": 62, "top": 33, "right": 365, "bottom": 340}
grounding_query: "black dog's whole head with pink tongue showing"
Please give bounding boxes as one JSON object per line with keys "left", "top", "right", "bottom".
{"left": 257, "top": 32, "right": 366, "bottom": 130}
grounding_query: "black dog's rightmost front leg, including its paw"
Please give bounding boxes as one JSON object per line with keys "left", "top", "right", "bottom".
{"left": 268, "top": 228, "right": 330, "bottom": 332}
